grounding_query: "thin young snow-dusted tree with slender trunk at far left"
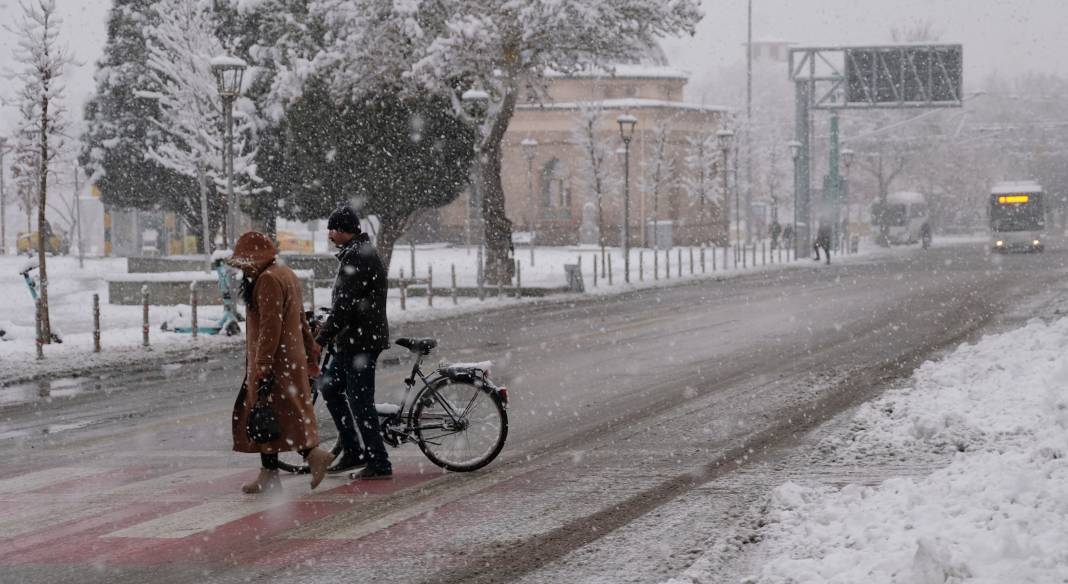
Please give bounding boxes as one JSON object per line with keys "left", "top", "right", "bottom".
{"left": 10, "top": 0, "right": 74, "bottom": 343}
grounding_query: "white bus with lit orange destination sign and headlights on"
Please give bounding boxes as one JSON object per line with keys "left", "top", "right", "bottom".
{"left": 989, "top": 180, "right": 1046, "bottom": 252}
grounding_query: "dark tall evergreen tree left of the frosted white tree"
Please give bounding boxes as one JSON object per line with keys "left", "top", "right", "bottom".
{"left": 79, "top": 0, "right": 200, "bottom": 228}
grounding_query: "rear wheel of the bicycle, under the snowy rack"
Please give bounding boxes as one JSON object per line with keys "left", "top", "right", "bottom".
{"left": 413, "top": 380, "right": 508, "bottom": 472}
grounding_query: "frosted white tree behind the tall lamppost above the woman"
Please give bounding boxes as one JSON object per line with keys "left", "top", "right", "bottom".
{"left": 139, "top": 0, "right": 261, "bottom": 248}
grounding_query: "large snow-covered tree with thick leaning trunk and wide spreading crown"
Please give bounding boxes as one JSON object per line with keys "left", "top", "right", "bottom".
{"left": 315, "top": 0, "right": 702, "bottom": 283}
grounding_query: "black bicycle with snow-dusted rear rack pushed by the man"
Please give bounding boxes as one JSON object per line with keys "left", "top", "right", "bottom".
{"left": 279, "top": 324, "right": 508, "bottom": 474}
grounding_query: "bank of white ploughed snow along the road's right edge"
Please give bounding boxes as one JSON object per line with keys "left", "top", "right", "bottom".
{"left": 747, "top": 319, "right": 1068, "bottom": 584}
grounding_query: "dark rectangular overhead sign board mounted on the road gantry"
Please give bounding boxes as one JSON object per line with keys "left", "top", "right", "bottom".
{"left": 844, "top": 45, "right": 963, "bottom": 107}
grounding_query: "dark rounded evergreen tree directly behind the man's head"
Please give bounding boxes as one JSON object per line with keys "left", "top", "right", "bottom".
{"left": 258, "top": 78, "right": 474, "bottom": 269}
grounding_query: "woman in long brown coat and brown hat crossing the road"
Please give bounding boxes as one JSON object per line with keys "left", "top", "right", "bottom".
{"left": 226, "top": 232, "right": 333, "bottom": 493}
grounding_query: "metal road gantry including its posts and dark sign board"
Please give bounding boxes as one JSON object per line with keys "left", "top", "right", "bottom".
{"left": 789, "top": 44, "right": 963, "bottom": 257}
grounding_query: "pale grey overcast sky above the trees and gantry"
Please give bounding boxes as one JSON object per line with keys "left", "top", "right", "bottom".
{"left": 0, "top": 0, "right": 1068, "bottom": 133}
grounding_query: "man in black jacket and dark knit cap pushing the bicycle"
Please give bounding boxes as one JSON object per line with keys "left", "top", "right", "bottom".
{"left": 315, "top": 205, "right": 393, "bottom": 479}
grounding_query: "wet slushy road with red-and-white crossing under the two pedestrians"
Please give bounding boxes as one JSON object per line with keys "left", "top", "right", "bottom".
{"left": 0, "top": 240, "right": 1068, "bottom": 583}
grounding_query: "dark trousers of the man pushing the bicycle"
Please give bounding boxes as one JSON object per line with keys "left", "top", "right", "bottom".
{"left": 319, "top": 351, "right": 392, "bottom": 470}
